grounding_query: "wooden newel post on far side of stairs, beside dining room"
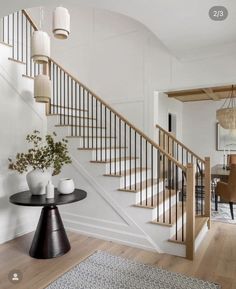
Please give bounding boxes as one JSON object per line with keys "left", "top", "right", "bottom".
{"left": 205, "top": 157, "right": 211, "bottom": 229}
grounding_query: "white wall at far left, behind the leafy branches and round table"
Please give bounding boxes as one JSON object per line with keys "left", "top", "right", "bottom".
{"left": 0, "top": 44, "right": 47, "bottom": 243}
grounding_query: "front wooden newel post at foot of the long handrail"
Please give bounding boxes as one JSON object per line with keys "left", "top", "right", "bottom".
{"left": 186, "top": 164, "right": 195, "bottom": 260}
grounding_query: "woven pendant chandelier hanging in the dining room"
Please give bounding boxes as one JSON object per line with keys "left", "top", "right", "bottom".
{"left": 216, "top": 85, "right": 236, "bottom": 129}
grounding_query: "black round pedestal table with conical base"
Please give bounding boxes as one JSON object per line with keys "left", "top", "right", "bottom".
{"left": 9, "top": 189, "right": 87, "bottom": 259}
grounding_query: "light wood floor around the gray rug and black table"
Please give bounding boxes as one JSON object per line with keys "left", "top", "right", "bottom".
{"left": 0, "top": 223, "right": 236, "bottom": 289}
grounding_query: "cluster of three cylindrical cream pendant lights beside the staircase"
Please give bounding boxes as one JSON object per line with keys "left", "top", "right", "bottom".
{"left": 31, "top": 7, "right": 70, "bottom": 103}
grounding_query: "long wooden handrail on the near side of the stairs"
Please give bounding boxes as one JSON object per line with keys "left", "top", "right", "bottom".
{"left": 50, "top": 58, "right": 186, "bottom": 172}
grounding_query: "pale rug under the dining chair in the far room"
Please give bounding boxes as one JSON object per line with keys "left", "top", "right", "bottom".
{"left": 211, "top": 202, "right": 236, "bottom": 224}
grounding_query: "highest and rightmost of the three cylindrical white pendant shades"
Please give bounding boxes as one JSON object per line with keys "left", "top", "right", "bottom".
{"left": 53, "top": 7, "right": 70, "bottom": 39}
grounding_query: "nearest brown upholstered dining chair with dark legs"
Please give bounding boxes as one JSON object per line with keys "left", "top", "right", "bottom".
{"left": 215, "top": 164, "right": 236, "bottom": 220}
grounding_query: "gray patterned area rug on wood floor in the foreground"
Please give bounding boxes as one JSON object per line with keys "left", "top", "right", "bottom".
{"left": 46, "top": 251, "right": 221, "bottom": 289}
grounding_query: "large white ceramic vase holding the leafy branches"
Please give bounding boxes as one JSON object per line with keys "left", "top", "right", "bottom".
{"left": 26, "top": 169, "right": 52, "bottom": 195}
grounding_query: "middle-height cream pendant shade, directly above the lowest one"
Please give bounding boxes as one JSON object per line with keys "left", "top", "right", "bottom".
{"left": 31, "top": 31, "right": 50, "bottom": 64}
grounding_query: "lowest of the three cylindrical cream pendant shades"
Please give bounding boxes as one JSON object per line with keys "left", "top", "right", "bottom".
{"left": 34, "top": 74, "right": 51, "bottom": 103}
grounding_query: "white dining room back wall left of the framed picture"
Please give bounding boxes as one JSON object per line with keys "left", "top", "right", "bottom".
{"left": 183, "top": 101, "right": 226, "bottom": 165}
